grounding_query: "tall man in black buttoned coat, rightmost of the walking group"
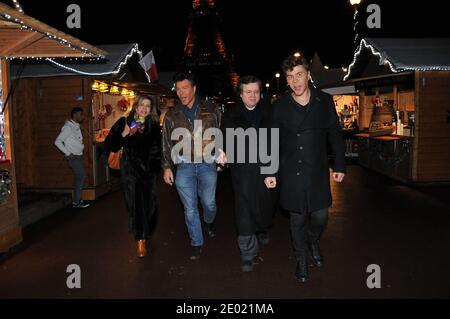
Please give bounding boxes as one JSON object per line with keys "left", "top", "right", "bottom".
{"left": 265, "top": 55, "right": 346, "bottom": 282}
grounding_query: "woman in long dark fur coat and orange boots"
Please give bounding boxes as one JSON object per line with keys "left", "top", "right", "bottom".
{"left": 105, "top": 95, "right": 161, "bottom": 258}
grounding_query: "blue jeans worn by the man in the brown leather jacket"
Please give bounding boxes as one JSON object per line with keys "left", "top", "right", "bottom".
{"left": 175, "top": 163, "right": 217, "bottom": 246}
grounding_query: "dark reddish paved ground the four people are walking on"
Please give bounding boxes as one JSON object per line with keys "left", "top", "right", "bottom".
{"left": 0, "top": 166, "right": 450, "bottom": 299}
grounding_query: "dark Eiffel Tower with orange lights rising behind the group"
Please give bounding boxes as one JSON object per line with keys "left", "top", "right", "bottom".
{"left": 179, "top": 0, "right": 238, "bottom": 100}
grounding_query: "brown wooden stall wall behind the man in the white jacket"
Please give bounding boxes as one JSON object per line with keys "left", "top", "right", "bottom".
{"left": 11, "top": 76, "right": 93, "bottom": 189}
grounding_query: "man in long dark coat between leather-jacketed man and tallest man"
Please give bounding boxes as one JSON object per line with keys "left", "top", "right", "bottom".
{"left": 222, "top": 76, "right": 277, "bottom": 272}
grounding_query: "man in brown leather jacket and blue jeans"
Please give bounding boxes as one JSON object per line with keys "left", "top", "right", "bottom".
{"left": 162, "top": 73, "right": 222, "bottom": 260}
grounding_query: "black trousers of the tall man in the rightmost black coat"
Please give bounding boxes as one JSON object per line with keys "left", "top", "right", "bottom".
{"left": 290, "top": 208, "right": 328, "bottom": 260}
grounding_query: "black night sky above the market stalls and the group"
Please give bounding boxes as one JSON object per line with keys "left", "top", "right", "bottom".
{"left": 14, "top": 0, "right": 450, "bottom": 80}
